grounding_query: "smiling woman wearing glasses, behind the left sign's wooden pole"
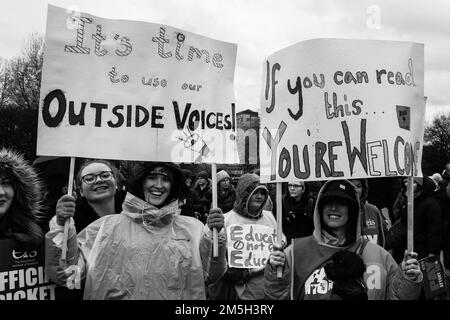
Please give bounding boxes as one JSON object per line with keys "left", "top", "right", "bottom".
{"left": 56, "top": 159, "right": 126, "bottom": 231}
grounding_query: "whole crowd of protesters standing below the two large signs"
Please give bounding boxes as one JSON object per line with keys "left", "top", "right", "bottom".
{"left": 0, "top": 149, "right": 450, "bottom": 300}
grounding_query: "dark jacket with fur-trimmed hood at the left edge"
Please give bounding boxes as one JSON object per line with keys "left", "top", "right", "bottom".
{"left": 0, "top": 149, "right": 45, "bottom": 248}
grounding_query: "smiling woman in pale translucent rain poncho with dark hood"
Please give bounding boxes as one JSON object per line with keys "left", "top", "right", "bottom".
{"left": 46, "top": 162, "right": 226, "bottom": 300}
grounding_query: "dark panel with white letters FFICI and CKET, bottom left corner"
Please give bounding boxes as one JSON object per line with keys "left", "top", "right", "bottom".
{"left": 0, "top": 239, "right": 81, "bottom": 300}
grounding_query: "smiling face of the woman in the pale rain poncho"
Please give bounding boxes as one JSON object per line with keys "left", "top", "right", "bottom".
{"left": 142, "top": 167, "right": 172, "bottom": 208}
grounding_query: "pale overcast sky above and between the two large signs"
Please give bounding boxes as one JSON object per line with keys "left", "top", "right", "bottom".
{"left": 0, "top": 0, "right": 450, "bottom": 120}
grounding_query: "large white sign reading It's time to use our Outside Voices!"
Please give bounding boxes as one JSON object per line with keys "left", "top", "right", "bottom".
{"left": 37, "top": 5, "right": 239, "bottom": 163}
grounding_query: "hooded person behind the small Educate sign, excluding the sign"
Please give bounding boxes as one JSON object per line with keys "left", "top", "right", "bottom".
{"left": 210, "top": 173, "right": 285, "bottom": 300}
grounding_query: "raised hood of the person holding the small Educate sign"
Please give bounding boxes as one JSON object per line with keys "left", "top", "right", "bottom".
{"left": 233, "top": 173, "right": 269, "bottom": 219}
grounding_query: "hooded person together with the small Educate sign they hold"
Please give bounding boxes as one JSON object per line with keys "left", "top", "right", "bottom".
{"left": 209, "top": 173, "right": 285, "bottom": 300}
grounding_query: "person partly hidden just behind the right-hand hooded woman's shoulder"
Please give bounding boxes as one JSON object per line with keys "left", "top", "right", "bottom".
{"left": 349, "top": 179, "right": 387, "bottom": 247}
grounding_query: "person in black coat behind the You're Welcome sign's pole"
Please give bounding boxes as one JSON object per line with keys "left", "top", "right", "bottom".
{"left": 386, "top": 176, "right": 443, "bottom": 261}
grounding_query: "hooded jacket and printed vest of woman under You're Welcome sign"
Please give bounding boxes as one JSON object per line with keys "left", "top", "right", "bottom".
{"left": 264, "top": 181, "right": 422, "bottom": 300}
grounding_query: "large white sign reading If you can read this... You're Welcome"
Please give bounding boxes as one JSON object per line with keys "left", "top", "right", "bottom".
{"left": 260, "top": 39, "right": 425, "bottom": 182}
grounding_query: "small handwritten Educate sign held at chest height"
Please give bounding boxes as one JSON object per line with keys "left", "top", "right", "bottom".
{"left": 227, "top": 224, "right": 276, "bottom": 269}
